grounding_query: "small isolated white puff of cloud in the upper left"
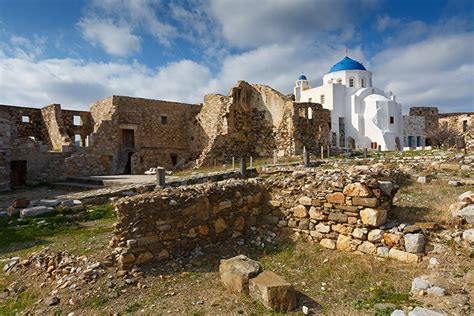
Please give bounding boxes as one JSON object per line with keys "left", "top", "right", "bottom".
{"left": 78, "top": 18, "right": 140, "bottom": 56}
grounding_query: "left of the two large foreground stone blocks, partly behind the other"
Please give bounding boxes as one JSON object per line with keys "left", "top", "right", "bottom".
{"left": 219, "top": 255, "right": 262, "bottom": 294}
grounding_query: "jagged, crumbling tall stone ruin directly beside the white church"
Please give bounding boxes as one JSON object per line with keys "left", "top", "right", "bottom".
{"left": 195, "top": 81, "right": 330, "bottom": 166}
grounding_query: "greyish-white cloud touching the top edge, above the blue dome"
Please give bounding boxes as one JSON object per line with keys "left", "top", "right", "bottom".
{"left": 210, "top": 0, "right": 374, "bottom": 48}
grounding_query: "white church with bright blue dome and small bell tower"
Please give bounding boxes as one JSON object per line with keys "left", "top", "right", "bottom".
{"left": 294, "top": 56, "right": 403, "bottom": 150}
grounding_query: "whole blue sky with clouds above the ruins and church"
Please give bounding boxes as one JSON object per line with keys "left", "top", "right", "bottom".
{"left": 0, "top": 0, "right": 474, "bottom": 112}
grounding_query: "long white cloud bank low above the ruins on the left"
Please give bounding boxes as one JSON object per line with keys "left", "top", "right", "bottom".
{"left": 0, "top": 54, "right": 210, "bottom": 109}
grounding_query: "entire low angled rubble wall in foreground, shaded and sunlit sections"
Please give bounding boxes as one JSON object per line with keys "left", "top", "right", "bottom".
{"left": 112, "top": 170, "right": 424, "bottom": 268}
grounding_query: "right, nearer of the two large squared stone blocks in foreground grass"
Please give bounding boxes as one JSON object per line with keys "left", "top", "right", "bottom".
{"left": 249, "top": 271, "right": 297, "bottom": 312}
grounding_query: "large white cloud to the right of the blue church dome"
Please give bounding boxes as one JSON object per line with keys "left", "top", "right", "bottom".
{"left": 372, "top": 33, "right": 474, "bottom": 112}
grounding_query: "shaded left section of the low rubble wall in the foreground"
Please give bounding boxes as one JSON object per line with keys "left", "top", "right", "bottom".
{"left": 113, "top": 180, "right": 263, "bottom": 268}
